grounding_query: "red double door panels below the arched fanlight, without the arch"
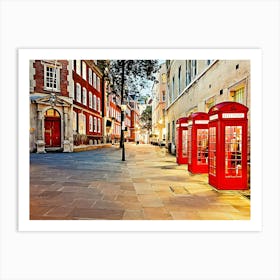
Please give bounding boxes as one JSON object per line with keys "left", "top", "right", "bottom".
{"left": 45, "top": 117, "right": 61, "bottom": 147}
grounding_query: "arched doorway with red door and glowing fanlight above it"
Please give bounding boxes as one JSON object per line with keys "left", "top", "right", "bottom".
{"left": 45, "top": 109, "right": 61, "bottom": 148}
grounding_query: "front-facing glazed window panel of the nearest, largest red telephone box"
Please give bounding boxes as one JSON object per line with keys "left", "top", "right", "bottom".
{"left": 225, "top": 126, "right": 242, "bottom": 178}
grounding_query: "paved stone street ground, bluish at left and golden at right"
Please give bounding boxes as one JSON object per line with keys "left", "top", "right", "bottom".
{"left": 30, "top": 143, "right": 250, "bottom": 220}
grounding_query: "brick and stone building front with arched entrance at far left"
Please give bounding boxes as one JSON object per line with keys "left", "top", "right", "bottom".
{"left": 29, "top": 60, "right": 73, "bottom": 153}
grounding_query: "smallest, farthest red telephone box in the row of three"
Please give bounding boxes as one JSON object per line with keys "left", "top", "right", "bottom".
{"left": 176, "top": 117, "right": 188, "bottom": 164}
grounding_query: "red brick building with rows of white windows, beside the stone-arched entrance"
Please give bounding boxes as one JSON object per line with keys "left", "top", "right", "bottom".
{"left": 72, "top": 60, "right": 103, "bottom": 145}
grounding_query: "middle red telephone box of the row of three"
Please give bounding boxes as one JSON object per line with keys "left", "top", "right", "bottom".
{"left": 188, "top": 112, "right": 209, "bottom": 173}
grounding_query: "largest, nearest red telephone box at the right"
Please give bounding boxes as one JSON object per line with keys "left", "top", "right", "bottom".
{"left": 208, "top": 101, "right": 248, "bottom": 190}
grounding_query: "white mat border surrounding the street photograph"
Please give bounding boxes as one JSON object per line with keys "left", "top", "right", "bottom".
{"left": 18, "top": 49, "right": 262, "bottom": 231}
